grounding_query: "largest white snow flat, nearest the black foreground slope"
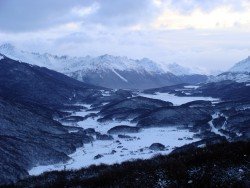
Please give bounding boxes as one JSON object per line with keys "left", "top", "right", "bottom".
{"left": 29, "top": 128, "right": 199, "bottom": 175}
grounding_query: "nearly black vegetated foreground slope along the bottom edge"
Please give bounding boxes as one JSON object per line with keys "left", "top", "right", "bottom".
{"left": 7, "top": 142, "right": 250, "bottom": 187}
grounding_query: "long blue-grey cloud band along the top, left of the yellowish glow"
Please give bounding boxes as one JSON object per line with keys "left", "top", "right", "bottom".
{"left": 0, "top": 0, "right": 156, "bottom": 32}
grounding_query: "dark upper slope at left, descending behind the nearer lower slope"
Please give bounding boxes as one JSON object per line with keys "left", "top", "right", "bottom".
{"left": 0, "top": 55, "right": 104, "bottom": 107}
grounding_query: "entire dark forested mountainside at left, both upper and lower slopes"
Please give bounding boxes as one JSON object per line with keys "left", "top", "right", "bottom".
{"left": 0, "top": 55, "right": 110, "bottom": 184}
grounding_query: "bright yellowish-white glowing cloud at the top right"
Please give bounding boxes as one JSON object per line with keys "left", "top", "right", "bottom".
{"left": 153, "top": 0, "right": 250, "bottom": 29}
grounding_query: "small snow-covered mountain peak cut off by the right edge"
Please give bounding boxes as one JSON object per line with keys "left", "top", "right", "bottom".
{"left": 210, "top": 56, "right": 250, "bottom": 82}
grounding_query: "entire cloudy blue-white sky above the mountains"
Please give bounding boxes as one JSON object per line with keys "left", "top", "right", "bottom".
{"left": 0, "top": 0, "right": 250, "bottom": 71}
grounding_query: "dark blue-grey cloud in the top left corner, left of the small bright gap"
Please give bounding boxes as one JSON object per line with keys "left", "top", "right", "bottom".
{"left": 0, "top": 0, "right": 92, "bottom": 32}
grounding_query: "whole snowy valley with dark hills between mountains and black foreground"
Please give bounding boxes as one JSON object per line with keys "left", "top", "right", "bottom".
{"left": 0, "top": 52, "right": 250, "bottom": 186}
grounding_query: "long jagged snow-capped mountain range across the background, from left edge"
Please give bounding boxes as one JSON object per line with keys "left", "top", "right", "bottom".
{"left": 0, "top": 44, "right": 207, "bottom": 89}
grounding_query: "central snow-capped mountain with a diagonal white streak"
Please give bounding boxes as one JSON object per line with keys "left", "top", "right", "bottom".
{"left": 64, "top": 55, "right": 181, "bottom": 89}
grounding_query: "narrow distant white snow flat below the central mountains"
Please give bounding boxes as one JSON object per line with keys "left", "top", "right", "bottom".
{"left": 139, "top": 92, "right": 218, "bottom": 105}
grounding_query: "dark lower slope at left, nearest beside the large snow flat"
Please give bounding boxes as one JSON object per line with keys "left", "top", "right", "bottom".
{"left": 0, "top": 98, "right": 92, "bottom": 185}
